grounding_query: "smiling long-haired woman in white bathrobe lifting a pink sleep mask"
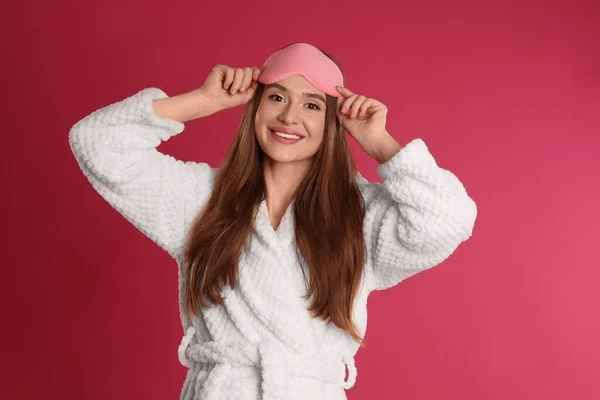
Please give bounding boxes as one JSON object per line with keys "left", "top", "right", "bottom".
{"left": 69, "top": 43, "right": 477, "bottom": 400}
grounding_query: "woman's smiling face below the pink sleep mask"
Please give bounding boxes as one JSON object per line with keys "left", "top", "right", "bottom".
{"left": 254, "top": 75, "right": 326, "bottom": 162}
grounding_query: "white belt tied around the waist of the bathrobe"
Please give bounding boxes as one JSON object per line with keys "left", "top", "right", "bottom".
{"left": 178, "top": 325, "right": 356, "bottom": 400}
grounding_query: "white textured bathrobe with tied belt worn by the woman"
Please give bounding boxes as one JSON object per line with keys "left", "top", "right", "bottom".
{"left": 69, "top": 88, "right": 477, "bottom": 400}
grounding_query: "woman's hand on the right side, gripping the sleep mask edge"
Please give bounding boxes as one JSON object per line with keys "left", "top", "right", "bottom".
{"left": 337, "top": 86, "right": 388, "bottom": 152}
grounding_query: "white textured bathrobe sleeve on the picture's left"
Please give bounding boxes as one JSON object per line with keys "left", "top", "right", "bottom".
{"left": 69, "top": 88, "right": 216, "bottom": 258}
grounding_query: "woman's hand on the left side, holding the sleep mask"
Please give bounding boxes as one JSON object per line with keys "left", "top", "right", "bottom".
{"left": 197, "top": 64, "right": 260, "bottom": 111}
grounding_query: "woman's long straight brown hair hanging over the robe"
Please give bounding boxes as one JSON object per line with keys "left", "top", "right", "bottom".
{"left": 184, "top": 46, "right": 366, "bottom": 346}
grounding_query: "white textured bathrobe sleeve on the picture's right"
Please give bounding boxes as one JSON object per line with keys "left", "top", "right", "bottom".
{"left": 358, "top": 139, "right": 477, "bottom": 290}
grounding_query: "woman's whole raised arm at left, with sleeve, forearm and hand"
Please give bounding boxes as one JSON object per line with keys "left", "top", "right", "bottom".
{"left": 69, "top": 64, "right": 260, "bottom": 258}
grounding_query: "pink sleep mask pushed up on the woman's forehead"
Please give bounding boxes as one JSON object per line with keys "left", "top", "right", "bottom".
{"left": 258, "top": 43, "right": 344, "bottom": 97}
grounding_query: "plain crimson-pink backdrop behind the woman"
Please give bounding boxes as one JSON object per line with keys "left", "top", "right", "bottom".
{"left": 0, "top": 0, "right": 600, "bottom": 400}
